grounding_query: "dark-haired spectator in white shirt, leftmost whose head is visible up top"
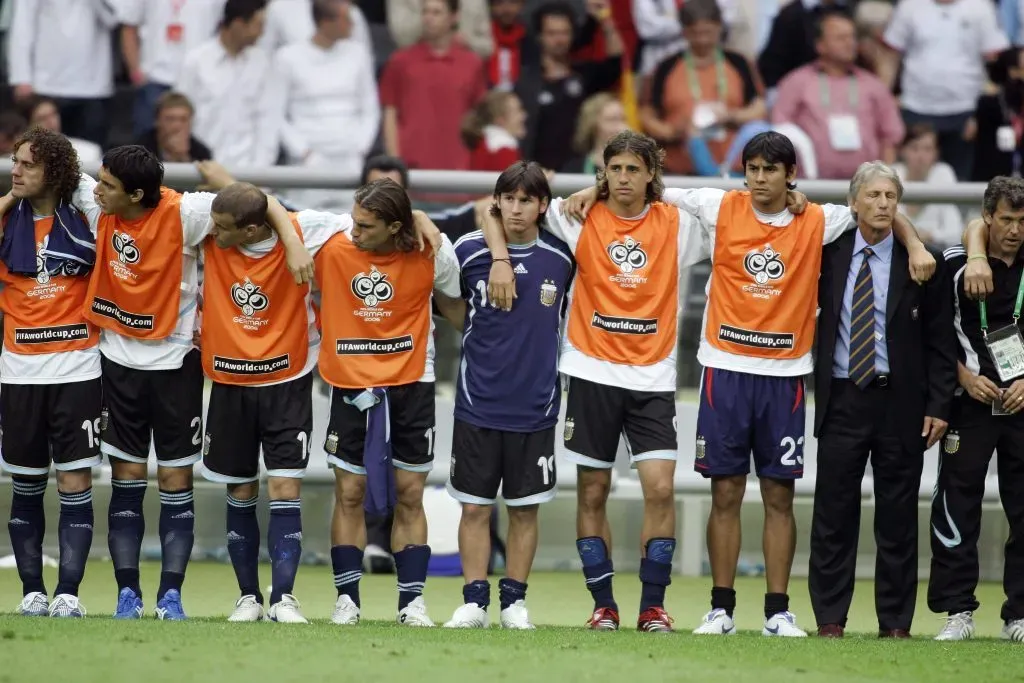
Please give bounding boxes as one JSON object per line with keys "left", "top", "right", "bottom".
{"left": 174, "top": 0, "right": 279, "bottom": 167}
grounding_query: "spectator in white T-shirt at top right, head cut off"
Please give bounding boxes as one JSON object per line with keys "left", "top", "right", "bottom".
{"left": 880, "top": 0, "right": 1010, "bottom": 180}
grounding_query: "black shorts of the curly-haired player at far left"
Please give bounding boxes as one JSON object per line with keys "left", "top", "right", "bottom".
{"left": 0, "top": 377, "right": 103, "bottom": 475}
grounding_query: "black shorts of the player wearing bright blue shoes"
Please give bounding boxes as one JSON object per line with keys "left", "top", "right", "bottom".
{"left": 100, "top": 349, "right": 203, "bottom": 467}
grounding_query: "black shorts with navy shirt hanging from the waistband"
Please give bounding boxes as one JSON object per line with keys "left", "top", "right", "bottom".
{"left": 324, "top": 382, "right": 436, "bottom": 474}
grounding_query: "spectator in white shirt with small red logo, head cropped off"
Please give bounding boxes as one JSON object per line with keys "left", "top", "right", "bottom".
{"left": 118, "top": 0, "right": 225, "bottom": 137}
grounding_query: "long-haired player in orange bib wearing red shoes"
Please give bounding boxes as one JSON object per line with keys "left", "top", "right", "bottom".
{"left": 484, "top": 131, "right": 709, "bottom": 632}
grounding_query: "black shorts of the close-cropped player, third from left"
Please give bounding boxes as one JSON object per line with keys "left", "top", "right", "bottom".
{"left": 203, "top": 373, "right": 313, "bottom": 483}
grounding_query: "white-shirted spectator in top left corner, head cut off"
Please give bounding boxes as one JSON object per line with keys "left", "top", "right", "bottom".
{"left": 7, "top": 0, "right": 118, "bottom": 145}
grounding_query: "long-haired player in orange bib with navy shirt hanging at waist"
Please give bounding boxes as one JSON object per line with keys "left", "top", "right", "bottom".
{"left": 316, "top": 179, "right": 460, "bottom": 627}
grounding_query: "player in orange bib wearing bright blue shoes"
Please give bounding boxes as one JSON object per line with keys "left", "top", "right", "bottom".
{"left": 74, "top": 145, "right": 312, "bottom": 620}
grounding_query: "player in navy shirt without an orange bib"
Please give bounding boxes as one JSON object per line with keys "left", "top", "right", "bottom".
{"left": 437, "top": 162, "right": 573, "bottom": 629}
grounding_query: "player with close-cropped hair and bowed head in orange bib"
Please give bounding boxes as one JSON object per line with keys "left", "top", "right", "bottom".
{"left": 201, "top": 182, "right": 351, "bottom": 624}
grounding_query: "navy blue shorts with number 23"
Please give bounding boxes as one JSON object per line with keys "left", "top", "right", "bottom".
{"left": 693, "top": 368, "right": 806, "bottom": 479}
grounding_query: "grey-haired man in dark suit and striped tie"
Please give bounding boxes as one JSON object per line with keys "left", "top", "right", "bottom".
{"left": 809, "top": 162, "right": 956, "bottom": 638}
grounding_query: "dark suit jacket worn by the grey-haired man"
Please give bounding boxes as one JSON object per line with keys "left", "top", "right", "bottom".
{"left": 814, "top": 230, "right": 956, "bottom": 451}
